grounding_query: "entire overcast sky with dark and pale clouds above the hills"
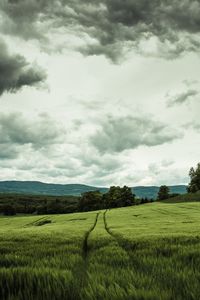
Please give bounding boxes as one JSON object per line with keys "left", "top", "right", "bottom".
{"left": 0, "top": 0, "right": 200, "bottom": 186}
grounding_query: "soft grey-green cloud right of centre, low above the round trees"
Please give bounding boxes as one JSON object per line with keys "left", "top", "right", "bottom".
{"left": 90, "top": 116, "right": 182, "bottom": 153}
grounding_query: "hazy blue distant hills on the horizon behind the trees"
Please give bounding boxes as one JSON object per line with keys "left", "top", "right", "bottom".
{"left": 0, "top": 181, "right": 186, "bottom": 199}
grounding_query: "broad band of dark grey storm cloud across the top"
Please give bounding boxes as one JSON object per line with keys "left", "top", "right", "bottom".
{"left": 0, "top": 0, "right": 200, "bottom": 61}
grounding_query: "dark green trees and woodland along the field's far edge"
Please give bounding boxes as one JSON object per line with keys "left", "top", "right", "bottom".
{"left": 0, "top": 163, "right": 200, "bottom": 216}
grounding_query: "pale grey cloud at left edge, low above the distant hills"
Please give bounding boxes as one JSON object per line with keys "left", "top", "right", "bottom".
{"left": 0, "top": 113, "right": 64, "bottom": 158}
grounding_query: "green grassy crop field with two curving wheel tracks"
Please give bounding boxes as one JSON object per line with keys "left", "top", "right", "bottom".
{"left": 0, "top": 202, "right": 200, "bottom": 300}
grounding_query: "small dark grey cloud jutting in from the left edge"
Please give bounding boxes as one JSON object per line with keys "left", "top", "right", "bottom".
{"left": 0, "top": 40, "right": 46, "bottom": 95}
